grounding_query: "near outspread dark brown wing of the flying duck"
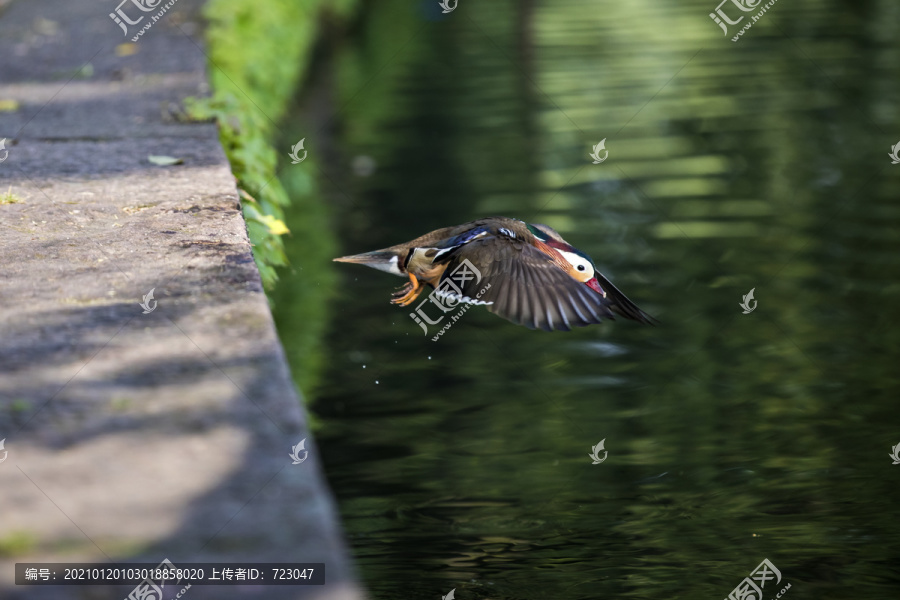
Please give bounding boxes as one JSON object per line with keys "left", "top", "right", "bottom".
{"left": 439, "top": 235, "right": 624, "bottom": 331}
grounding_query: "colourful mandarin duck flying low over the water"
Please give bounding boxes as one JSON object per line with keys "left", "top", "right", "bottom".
{"left": 334, "top": 217, "right": 656, "bottom": 331}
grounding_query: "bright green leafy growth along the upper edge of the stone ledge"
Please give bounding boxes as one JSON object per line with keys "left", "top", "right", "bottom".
{"left": 185, "top": 0, "right": 356, "bottom": 290}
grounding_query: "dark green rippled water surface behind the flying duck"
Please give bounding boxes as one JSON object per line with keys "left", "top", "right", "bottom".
{"left": 277, "top": 0, "right": 900, "bottom": 600}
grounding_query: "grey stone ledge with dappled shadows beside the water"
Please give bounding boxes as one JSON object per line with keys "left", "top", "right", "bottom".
{"left": 0, "top": 0, "right": 362, "bottom": 600}
